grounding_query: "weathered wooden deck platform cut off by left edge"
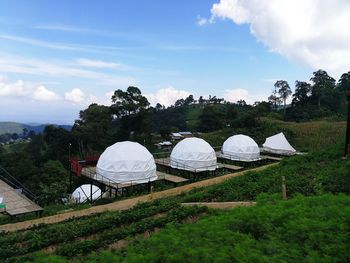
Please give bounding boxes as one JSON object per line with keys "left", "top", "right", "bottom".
{"left": 0, "top": 180, "right": 43, "bottom": 216}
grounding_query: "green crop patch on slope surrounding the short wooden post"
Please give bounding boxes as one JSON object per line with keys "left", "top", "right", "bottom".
{"left": 184, "top": 145, "right": 350, "bottom": 202}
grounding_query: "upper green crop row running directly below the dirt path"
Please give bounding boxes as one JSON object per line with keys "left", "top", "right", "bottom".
{"left": 0, "top": 199, "right": 179, "bottom": 258}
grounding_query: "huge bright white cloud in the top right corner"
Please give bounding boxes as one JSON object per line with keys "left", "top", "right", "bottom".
{"left": 210, "top": 0, "right": 350, "bottom": 77}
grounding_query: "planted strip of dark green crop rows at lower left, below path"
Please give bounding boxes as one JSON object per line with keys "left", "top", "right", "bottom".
{"left": 0, "top": 199, "right": 208, "bottom": 262}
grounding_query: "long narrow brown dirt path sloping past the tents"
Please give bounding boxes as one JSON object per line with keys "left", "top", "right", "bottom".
{"left": 0, "top": 163, "right": 277, "bottom": 232}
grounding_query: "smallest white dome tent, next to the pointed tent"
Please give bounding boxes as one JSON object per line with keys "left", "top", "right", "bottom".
{"left": 221, "top": 134, "right": 260, "bottom": 161}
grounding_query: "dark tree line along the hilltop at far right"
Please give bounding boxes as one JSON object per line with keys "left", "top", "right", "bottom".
{"left": 268, "top": 69, "right": 350, "bottom": 121}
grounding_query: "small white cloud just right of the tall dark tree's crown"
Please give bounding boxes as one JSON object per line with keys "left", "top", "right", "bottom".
{"left": 145, "top": 87, "right": 191, "bottom": 107}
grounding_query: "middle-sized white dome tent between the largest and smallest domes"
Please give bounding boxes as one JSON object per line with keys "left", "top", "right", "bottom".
{"left": 170, "top": 137, "right": 217, "bottom": 172}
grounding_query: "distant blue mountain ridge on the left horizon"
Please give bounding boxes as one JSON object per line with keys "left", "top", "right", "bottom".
{"left": 0, "top": 121, "right": 73, "bottom": 135}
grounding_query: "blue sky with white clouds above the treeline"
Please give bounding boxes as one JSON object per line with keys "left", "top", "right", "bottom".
{"left": 0, "top": 0, "right": 350, "bottom": 124}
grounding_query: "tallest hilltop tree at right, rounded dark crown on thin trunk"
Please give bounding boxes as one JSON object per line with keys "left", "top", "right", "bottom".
{"left": 310, "top": 69, "right": 335, "bottom": 109}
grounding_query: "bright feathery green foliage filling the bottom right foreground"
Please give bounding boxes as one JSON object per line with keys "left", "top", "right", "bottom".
{"left": 107, "top": 195, "right": 350, "bottom": 262}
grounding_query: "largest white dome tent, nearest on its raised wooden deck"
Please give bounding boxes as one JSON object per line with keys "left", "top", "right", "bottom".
{"left": 96, "top": 141, "right": 157, "bottom": 184}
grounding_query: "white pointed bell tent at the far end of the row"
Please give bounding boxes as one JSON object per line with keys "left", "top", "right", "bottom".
{"left": 263, "top": 132, "right": 296, "bottom": 155}
